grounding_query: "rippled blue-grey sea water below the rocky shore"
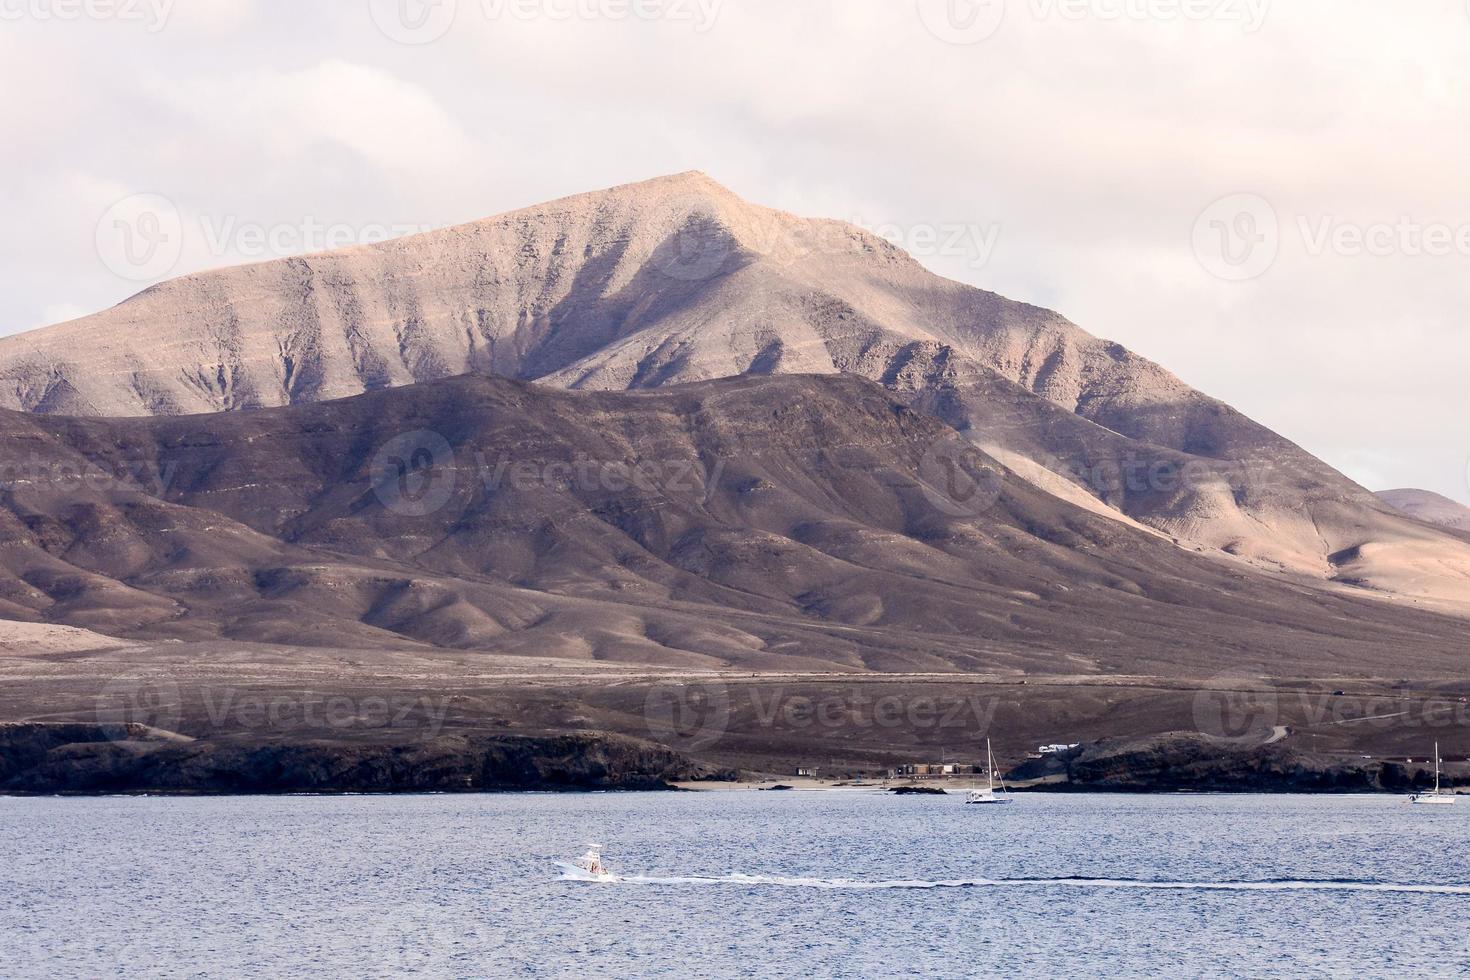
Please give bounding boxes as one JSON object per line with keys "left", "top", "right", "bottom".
{"left": 0, "top": 790, "right": 1470, "bottom": 977}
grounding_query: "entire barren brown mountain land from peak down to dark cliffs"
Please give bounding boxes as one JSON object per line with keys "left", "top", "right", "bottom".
{"left": 0, "top": 175, "right": 1470, "bottom": 779}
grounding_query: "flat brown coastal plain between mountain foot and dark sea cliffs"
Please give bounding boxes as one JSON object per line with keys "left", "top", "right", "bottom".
{"left": 0, "top": 644, "right": 1470, "bottom": 790}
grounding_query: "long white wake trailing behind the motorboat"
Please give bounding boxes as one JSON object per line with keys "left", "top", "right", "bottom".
{"left": 563, "top": 871, "right": 1470, "bottom": 895}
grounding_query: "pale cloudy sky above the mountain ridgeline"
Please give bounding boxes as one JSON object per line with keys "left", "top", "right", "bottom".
{"left": 0, "top": 0, "right": 1470, "bottom": 502}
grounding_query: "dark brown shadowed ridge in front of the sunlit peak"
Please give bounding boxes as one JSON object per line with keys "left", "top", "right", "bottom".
{"left": 0, "top": 375, "right": 1464, "bottom": 676}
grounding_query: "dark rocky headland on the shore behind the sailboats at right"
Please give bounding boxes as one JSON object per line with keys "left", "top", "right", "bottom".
{"left": 1007, "top": 733, "right": 1448, "bottom": 793}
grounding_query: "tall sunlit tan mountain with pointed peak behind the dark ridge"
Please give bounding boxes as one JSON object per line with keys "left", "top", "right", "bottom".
{"left": 0, "top": 173, "right": 1470, "bottom": 610}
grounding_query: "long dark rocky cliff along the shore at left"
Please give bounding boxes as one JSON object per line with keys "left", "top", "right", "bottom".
{"left": 0, "top": 724, "right": 709, "bottom": 793}
